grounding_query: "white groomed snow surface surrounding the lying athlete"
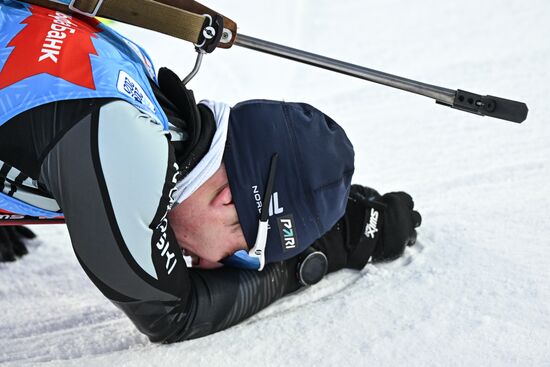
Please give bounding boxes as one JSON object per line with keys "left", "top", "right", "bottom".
{"left": 0, "top": 0, "right": 550, "bottom": 367}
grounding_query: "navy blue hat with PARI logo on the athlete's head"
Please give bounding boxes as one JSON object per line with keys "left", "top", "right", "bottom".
{"left": 223, "top": 100, "right": 354, "bottom": 270}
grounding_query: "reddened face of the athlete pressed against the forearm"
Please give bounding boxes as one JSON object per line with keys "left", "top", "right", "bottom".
{"left": 168, "top": 164, "right": 247, "bottom": 268}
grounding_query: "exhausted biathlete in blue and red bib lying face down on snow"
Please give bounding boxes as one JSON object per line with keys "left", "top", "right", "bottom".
{"left": 0, "top": 0, "right": 421, "bottom": 342}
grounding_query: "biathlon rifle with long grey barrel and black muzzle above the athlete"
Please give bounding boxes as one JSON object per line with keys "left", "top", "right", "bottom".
{"left": 21, "top": 0, "right": 528, "bottom": 123}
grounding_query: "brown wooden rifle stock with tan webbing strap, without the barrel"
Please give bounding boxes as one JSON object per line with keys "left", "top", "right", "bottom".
{"left": 24, "top": 0, "right": 237, "bottom": 48}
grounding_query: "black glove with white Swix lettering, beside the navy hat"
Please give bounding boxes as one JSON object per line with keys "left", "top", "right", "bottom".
{"left": 313, "top": 185, "right": 422, "bottom": 273}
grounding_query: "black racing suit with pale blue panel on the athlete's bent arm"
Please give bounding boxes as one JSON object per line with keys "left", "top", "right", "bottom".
{"left": 0, "top": 77, "right": 336, "bottom": 343}
